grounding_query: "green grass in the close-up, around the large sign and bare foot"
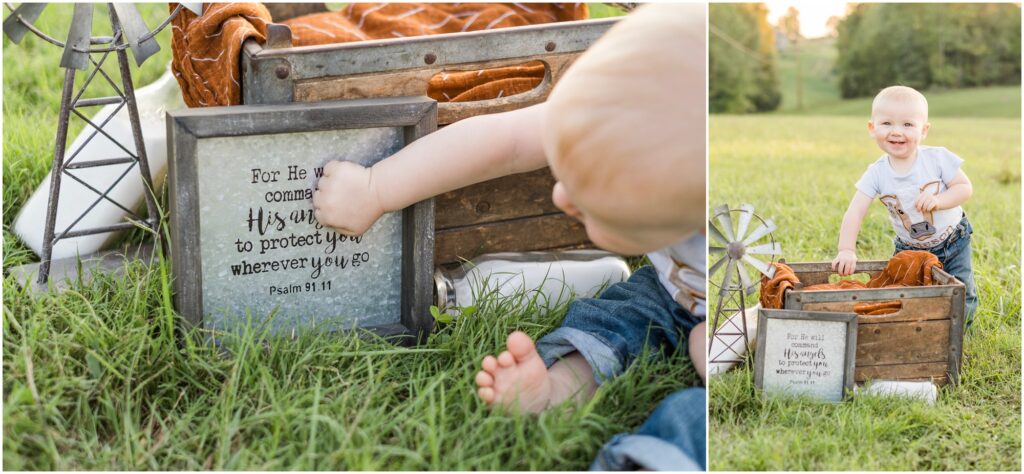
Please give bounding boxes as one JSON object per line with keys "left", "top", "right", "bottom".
{"left": 3, "top": 5, "right": 698, "bottom": 471}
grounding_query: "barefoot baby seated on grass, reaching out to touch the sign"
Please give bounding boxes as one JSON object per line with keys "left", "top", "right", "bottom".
{"left": 313, "top": 4, "right": 707, "bottom": 470}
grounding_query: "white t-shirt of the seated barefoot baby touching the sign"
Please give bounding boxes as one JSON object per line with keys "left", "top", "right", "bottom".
{"left": 647, "top": 232, "right": 708, "bottom": 318}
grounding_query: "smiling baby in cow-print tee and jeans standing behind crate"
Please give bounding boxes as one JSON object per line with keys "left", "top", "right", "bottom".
{"left": 833, "top": 86, "right": 978, "bottom": 328}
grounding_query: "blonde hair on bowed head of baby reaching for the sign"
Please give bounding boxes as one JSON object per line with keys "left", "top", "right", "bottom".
{"left": 544, "top": 4, "right": 707, "bottom": 232}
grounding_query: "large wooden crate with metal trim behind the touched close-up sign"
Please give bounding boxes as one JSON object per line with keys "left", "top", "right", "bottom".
{"left": 242, "top": 16, "right": 616, "bottom": 264}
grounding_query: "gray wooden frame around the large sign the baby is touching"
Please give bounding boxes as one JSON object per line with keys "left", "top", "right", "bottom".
{"left": 167, "top": 97, "right": 437, "bottom": 341}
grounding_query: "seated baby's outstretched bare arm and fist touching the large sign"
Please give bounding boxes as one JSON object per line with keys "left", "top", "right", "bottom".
{"left": 313, "top": 103, "right": 547, "bottom": 235}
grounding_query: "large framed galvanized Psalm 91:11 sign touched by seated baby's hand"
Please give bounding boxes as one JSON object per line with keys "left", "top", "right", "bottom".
{"left": 170, "top": 99, "right": 435, "bottom": 341}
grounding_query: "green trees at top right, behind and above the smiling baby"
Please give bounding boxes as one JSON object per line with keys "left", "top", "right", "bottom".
{"left": 836, "top": 3, "right": 1021, "bottom": 98}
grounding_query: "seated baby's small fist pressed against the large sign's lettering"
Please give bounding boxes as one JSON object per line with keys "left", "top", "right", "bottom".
{"left": 313, "top": 161, "right": 384, "bottom": 235}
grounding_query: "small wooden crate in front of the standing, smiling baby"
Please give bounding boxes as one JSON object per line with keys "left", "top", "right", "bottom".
{"left": 783, "top": 261, "right": 966, "bottom": 385}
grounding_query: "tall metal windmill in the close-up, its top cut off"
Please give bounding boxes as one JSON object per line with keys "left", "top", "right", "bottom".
{"left": 3, "top": 3, "right": 197, "bottom": 285}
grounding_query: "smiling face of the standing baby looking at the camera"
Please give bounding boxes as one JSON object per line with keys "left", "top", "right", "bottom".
{"left": 867, "top": 100, "right": 930, "bottom": 160}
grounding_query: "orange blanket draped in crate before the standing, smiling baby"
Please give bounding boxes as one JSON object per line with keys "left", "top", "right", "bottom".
{"left": 761, "top": 250, "right": 942, "bottom": 315}
